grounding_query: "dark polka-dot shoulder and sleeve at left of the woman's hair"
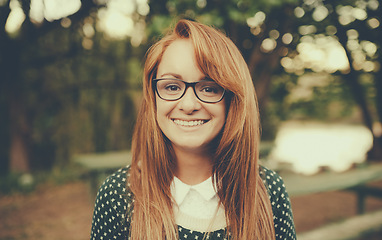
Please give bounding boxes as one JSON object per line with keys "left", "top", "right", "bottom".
{"left": 91, "top": 167, "right": 134, "bottom": 239}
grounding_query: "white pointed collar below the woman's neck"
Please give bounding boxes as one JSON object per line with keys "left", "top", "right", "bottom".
{"left": 171, "top": 176, "right": 216, "bottom": 206}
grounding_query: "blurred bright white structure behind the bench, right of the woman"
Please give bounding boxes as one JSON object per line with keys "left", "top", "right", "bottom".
{"left": 269, "top": 122, "right": 373, "bottom": 175}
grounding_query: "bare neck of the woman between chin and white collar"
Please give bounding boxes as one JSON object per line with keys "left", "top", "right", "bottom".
{"left": 174, "top": 146, "right": 212, "bottom": 185}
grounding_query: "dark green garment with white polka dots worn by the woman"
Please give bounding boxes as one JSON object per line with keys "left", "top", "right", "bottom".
{"left": 91, "top": 167, "right": 296, "bottom": 240}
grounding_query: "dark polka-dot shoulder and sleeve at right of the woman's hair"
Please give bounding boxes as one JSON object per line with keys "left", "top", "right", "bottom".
{"left": 259, "top": 166, "right": 296, "bottom": 239}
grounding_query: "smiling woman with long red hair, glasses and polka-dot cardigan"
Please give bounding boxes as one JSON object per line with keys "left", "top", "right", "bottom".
{"left": 91, "top": 20, "right": 295, "bottom": 240}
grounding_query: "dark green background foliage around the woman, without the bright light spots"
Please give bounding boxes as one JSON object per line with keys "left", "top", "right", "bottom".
{"left": 0, "top": 0, "right": 382, "bottom": 172}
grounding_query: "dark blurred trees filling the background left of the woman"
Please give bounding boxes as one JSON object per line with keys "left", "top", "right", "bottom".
{"left": 0, "top": 0, "right": 142, "bottom": 172}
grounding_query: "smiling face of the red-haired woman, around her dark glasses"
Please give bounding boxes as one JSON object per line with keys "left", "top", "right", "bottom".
{"left": 156, "top": 39, "right": 226, "bottom": 151}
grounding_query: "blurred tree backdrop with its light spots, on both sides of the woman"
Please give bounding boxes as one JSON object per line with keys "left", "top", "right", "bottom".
{"left": 0, "top": 0, "right": 382, "bottom": 174}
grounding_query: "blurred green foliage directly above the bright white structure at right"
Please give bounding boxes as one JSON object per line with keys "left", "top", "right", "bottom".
{"left": 270, "top": 73, "right": 355, "bottom": 121}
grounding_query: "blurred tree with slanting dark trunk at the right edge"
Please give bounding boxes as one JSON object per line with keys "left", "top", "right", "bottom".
{"left": 282, "top": 0, "right": 382, "bottom": 160}
